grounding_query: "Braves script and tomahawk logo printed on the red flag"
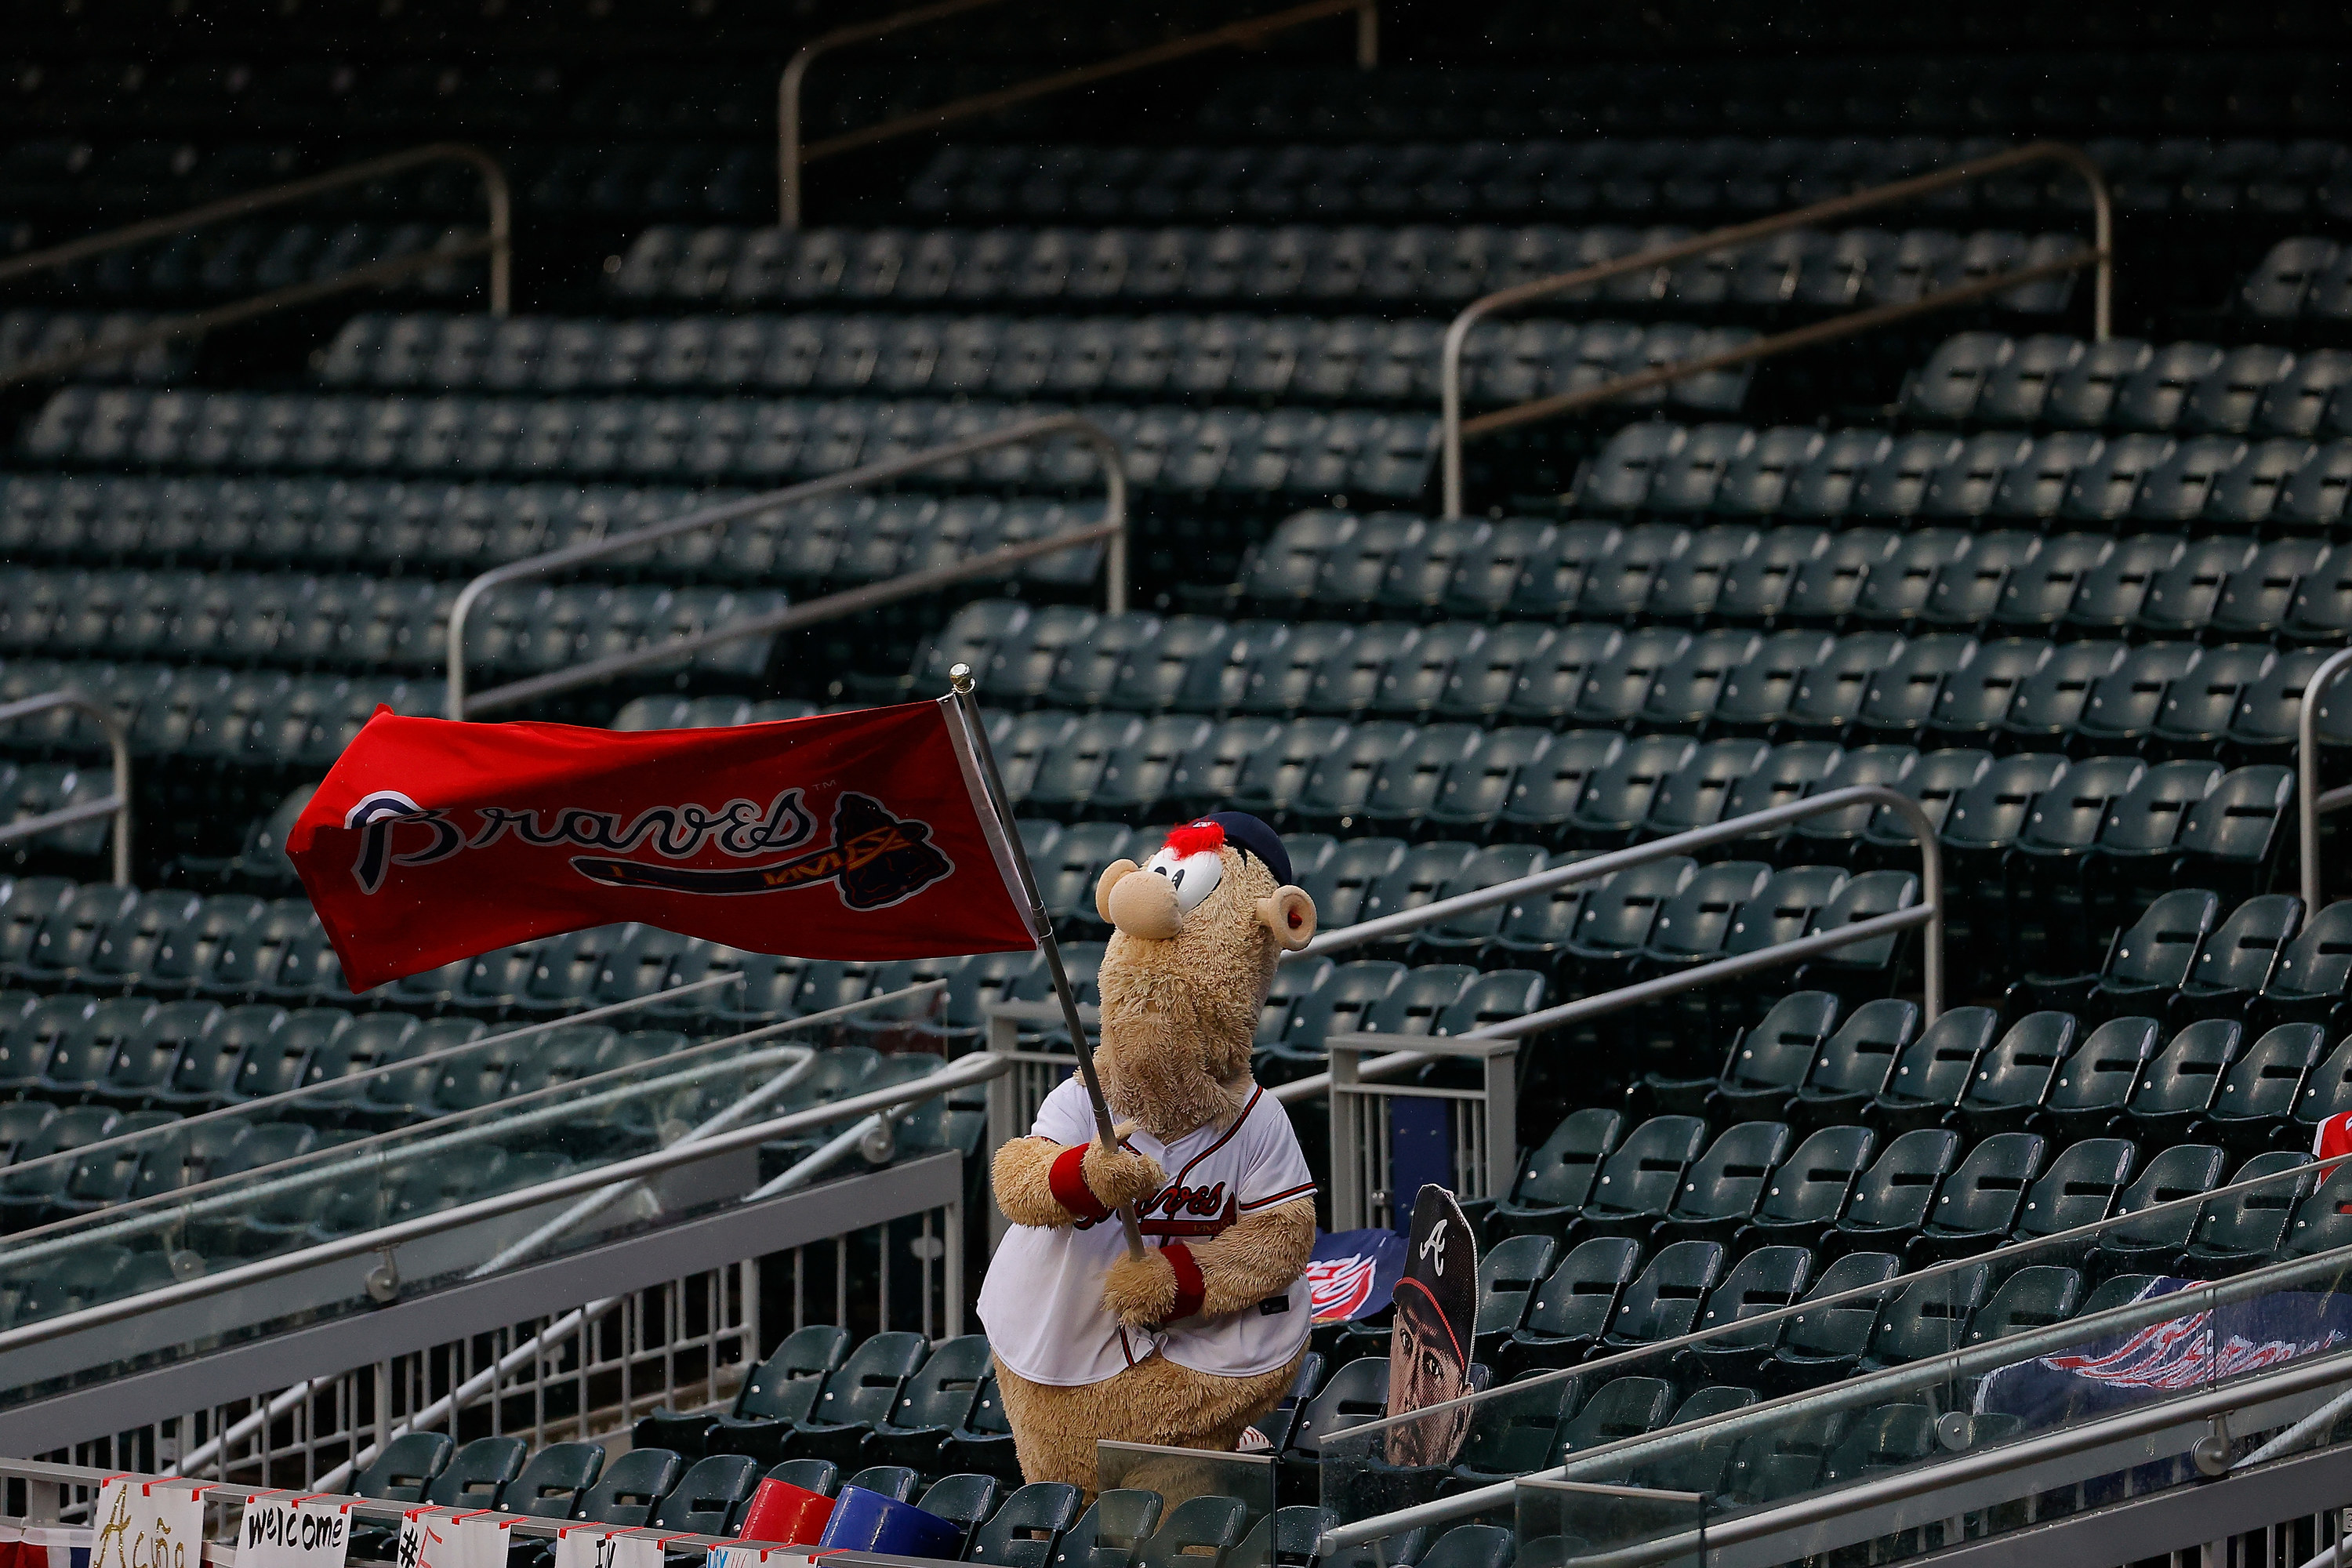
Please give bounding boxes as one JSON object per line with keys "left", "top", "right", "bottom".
{"left": 343, "top": 789, "right": 955, "bottom": 909}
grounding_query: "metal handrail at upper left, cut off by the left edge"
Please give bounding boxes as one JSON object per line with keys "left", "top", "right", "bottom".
{"left": 0, "top": 141, "right": 515, "bottom": 386}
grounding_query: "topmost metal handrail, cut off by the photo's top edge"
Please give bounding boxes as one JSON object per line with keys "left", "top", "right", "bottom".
{"left": 776, "top": 0, "right": 1381, "bottom": 228}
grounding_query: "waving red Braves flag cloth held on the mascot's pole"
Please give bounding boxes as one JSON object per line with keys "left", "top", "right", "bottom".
{"left": 287, "top": 701, "right": 1035, "bottom": 989}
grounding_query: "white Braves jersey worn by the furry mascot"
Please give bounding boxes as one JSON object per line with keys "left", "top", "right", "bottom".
{"left": 978, "top": 1074, "right": 1315, "bottom": 1387}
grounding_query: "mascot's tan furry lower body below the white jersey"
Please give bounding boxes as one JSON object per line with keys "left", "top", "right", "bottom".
{"left": 997, "top": 1349, "right": 1305, "bottom": 1502}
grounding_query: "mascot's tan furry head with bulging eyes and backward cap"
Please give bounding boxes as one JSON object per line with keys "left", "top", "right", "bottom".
{"left": 1094, "top": 811, "right": 1315, "bottom": 1142}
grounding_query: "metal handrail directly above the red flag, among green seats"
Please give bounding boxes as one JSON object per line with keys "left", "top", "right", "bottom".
{"left": 442, "top": 414, "right": 1127, "bottom": 720}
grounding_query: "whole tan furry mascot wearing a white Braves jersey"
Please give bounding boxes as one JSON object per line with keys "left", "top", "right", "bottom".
{"left": 978, "top": 811, "right": 1315, "bottom": 1495}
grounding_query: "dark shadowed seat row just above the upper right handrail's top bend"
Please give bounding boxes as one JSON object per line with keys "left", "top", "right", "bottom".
{"left": 1197, "top": 57, "right": 2345, "bottom": 141}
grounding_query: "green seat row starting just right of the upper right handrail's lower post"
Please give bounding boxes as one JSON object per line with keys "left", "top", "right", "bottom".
{"left": 1571, "top": 420, "right": 2352, "bottom": 532}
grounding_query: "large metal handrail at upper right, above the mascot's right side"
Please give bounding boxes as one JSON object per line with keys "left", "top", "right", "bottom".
{"left": 1437, "top": 141, "right": 2114, "bottom": 517}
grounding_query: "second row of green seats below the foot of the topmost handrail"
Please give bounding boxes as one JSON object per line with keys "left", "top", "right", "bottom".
{"left": 320, "top": 310, "right": 1755, "bottom": 412}
